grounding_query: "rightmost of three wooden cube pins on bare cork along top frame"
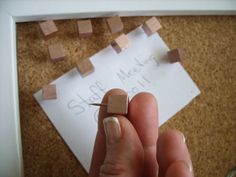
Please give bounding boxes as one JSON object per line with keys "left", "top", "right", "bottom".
{"left": 107, "top": 16, "right": 124, "bottom": 34}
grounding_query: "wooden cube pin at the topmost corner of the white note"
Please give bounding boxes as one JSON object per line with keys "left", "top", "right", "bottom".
{"left": 143, "top": 17, "right": 161, "bottom": 36}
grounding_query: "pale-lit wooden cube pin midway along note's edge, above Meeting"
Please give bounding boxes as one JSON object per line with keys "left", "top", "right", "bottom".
{"left": 111, "top": 34, "right": 129, "bottom": 53}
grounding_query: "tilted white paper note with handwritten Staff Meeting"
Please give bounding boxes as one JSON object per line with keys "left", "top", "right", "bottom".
{"left": 34, "top": 27, "right": 200, "bottom": 171}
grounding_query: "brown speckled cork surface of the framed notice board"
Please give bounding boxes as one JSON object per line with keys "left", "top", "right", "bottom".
{"left": 17, "top": 16, "right": 236, "bottom": 177}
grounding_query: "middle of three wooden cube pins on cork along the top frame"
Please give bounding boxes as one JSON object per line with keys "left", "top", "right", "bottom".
{"left": 78, "top": 20, "right": 93, "bottom": 37}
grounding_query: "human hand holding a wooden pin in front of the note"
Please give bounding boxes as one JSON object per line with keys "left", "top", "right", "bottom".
{"left": 89, "top": 89, "right": 193, "bottom": 177}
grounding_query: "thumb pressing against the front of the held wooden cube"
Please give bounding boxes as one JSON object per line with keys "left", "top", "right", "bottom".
{"left": 99, "top": 116, "right": 144, "bottom": 177}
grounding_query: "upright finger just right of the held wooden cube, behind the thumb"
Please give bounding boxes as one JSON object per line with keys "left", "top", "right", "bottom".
{"left": 128, "top": 92, "right": 158, "bottom": 177}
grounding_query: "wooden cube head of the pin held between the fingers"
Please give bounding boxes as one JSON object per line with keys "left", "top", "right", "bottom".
{"left": 107, "top": 95, "right": 129, "bottom": 115}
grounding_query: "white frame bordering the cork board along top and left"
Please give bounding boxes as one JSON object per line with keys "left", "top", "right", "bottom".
{"left": 0, "top": 0, "right": 236, "bottom": 177}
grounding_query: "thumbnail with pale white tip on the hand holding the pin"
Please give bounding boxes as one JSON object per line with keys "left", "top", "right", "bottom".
{"left": 103, "top": 117, "right": 121, "bottom": 144}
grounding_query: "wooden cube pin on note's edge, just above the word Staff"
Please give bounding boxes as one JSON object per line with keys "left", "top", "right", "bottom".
{"left": 77, "top": 59, "right": 94, "bottom": 77}
